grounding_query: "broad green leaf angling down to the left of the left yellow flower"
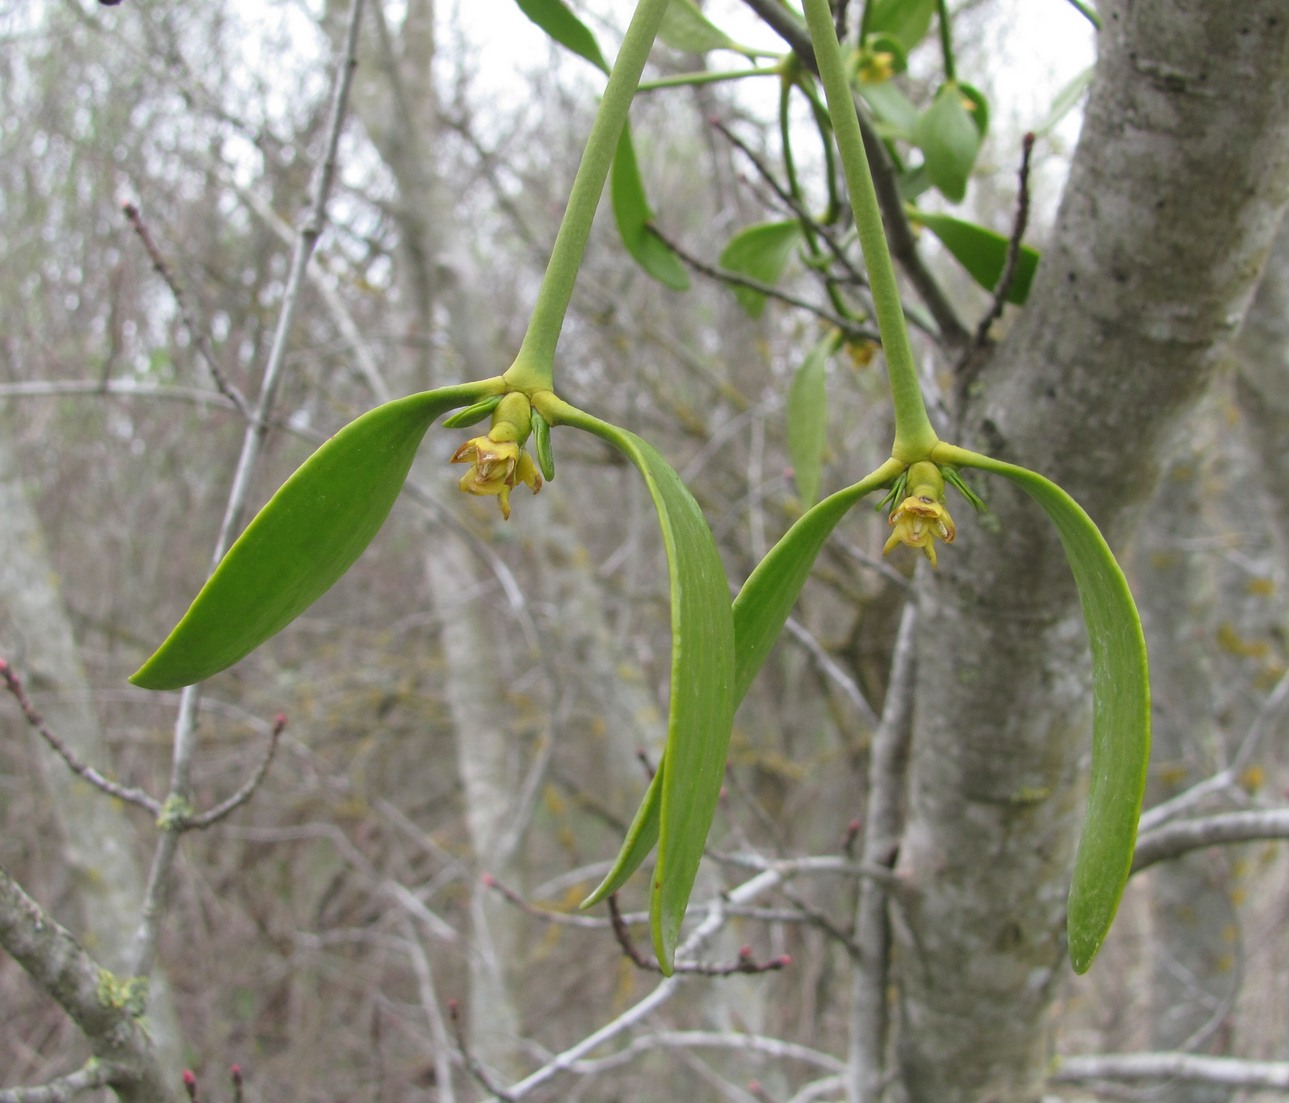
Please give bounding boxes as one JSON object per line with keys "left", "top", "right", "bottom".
{"left": 130, "top": 379, "right": 500, "bottom": 689}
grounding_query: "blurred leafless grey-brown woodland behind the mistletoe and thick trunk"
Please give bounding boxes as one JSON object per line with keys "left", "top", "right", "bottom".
{"left": 0, "top": 0, "right": 1289, "bottom": 1103}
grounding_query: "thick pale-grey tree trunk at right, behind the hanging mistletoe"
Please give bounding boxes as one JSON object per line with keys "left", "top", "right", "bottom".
{"left": 895, "top": 0, "right": 1289, "bottom": 1103}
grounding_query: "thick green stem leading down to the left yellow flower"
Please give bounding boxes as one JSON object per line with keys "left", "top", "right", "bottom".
{"left": 505, "top": 0, "right": 668, "bottom": 394}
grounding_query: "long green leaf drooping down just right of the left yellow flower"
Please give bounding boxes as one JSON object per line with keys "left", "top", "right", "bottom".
{"left": 556, "top": 403, "right": 735, "bottom": 973}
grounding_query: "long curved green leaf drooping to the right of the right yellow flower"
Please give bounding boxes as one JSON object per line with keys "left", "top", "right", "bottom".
{"left": 936, "top": 446, "right": 1150, "bottom": 973}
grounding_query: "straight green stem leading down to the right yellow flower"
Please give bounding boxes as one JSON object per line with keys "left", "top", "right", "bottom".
{"left": 806, "top": 0, "right": 937, "bottom": 464}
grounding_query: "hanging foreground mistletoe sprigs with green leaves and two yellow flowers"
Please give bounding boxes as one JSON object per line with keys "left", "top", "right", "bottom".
{"left": 130, "top": 0, "right": 1150, "bottom": 972}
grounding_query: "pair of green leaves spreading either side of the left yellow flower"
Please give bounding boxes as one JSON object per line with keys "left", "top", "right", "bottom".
{"left": 130, "top": 378, "right": 735, "bottom": 969}
